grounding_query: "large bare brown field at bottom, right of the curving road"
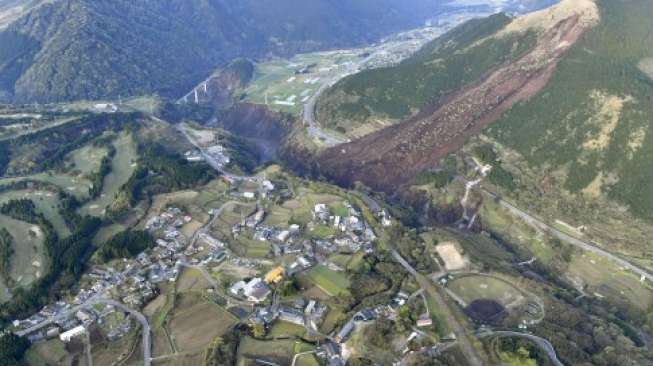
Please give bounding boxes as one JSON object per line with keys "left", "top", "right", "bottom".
{"left": 169, "top": 302, "right": 236, "bottom": 352}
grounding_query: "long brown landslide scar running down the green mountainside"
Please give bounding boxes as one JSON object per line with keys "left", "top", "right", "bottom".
{"left": 318, "top": 0, "right": 598, "bottom": 193}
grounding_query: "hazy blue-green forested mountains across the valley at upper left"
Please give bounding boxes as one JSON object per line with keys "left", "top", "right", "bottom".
{"left": 0, "top": 0, "right": 442, "bottom": 101}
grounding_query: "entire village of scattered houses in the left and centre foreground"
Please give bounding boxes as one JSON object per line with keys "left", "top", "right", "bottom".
{"left": 7, "top": 162, "right": 430, "bottom": 365}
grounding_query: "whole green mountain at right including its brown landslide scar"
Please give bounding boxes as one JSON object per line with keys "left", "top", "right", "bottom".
{"left": 318, "top": 0, "right": 653, "bottom": 232}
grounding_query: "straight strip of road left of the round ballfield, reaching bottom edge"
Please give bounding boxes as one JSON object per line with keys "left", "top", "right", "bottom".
{"left": 392, "top": 250, "right": 483, "bottom": 366}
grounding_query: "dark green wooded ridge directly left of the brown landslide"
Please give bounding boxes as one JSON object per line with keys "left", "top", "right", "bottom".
{"left": 317, "top": 14, "right": 535, "bottom": 137}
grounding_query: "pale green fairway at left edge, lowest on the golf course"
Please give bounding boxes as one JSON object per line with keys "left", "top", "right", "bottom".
{"left": 0, "top": 215, "right": 47, "bottom": 294}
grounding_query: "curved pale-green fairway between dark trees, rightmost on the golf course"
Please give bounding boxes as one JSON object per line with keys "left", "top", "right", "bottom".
{"left": 81, "top": 133, "right": 137, "bottom": 216}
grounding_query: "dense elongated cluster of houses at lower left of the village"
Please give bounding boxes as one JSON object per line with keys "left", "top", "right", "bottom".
{"left": 13, "top": 207, "right": 224, "bottom": 342}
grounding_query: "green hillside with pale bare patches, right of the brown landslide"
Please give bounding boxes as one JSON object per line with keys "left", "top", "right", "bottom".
{"left": 489, "top": 0, "right": 653, "bottom": 219}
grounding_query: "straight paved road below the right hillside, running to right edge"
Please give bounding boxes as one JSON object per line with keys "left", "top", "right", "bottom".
{"left": 481, "top": 189, "right": 653, "bottom": 281}
